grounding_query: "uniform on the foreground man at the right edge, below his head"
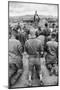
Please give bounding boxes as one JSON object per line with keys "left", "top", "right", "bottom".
{"left": 46, "top": 40, "right": 58, "bottom": 64}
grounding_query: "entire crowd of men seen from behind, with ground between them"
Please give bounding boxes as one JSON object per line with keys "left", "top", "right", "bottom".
{"left": 8, "top": 14, "right": 58, "bottom": 88}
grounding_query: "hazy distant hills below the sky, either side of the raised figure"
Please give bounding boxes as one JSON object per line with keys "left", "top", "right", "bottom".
{"left": 9, "top": 15, "right": 57, "bottom": 23}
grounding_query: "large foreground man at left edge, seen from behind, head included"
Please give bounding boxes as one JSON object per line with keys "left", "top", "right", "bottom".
{"left": 8, "top": 30, "right": 23, "bottom": 88}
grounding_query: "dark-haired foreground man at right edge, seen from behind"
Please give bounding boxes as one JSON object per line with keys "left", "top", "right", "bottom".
{"left": 45, "top": 33, "right": 58, "bottom": 75}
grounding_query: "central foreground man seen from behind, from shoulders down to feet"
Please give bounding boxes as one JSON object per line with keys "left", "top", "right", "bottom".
{"left": 25, "top": 38, "right": 43, "bottom": 85}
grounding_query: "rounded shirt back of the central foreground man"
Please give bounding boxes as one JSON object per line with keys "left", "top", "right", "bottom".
{"left": 25, "top": 38, "right": 42, "bottom": 55}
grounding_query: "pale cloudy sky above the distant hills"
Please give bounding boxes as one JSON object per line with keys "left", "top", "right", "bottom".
{"left": 9, "top": 2, "right": 58, "bottom": 17}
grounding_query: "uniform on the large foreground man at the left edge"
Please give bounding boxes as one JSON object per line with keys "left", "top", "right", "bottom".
{"left": 8, "top": 38, "right": 23, "bottom": 84}
